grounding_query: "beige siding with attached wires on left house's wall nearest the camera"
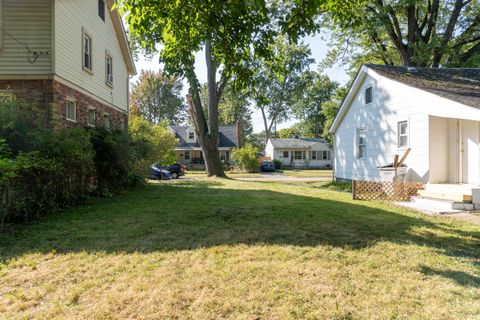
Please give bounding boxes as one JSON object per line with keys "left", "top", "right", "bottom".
{"left": 0, "top": 0, "right": 53, "bottom": 79}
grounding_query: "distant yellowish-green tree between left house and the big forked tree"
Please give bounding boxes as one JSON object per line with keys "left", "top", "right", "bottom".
{"left": 130, "top": 70, "right": 187, "bottom": 124}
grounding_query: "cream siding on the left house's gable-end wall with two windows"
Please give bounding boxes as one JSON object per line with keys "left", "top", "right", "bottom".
{"left": 55, "top": 0, "right": 128, "bottom": 111}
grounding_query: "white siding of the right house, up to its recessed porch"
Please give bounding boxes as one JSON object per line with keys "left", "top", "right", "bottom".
{"left": 334, "top": 75, "right": 429, "bottom": 181}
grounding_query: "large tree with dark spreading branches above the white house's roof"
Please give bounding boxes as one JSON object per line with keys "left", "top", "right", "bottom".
{"left": 324, "top": 0, "right": 480, "bottom": 68}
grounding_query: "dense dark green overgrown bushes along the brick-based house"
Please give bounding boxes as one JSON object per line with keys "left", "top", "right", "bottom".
{"left": 0, "top": 101, "right": 175, "bottom": 227}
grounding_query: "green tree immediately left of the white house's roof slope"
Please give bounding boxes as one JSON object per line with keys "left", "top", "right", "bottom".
{"left": 293, "top": 71, "right": 338, "bottom": 137}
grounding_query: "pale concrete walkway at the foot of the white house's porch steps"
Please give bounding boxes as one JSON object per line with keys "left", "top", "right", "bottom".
{"left": 394, "top": 199, "right": 480, "bottom": 225}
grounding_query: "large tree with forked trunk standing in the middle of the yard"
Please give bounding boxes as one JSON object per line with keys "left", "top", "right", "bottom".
{"left": 120, "top": 0, "right": 276, "bottom": 177}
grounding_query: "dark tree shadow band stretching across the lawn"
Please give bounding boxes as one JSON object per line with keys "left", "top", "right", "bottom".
{"left": 0, "top": 181, "right": 480, "bottom": 276}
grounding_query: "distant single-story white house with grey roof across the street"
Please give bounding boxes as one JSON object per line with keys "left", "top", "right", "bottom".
{"left": 265, "top": 138, "right": 332, "bottom": 168}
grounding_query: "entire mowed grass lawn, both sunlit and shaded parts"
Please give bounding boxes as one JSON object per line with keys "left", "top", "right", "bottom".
{"left": 0, "top": 179, "right": 480, "bottom": 319}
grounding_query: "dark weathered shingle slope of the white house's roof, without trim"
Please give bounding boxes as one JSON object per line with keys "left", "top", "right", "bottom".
{"left": 366, "top": 64, "right": 480, "bottom": 109}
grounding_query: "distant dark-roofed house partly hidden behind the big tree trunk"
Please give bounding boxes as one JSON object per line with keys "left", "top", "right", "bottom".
{"left": 169, "top": 124, "right": 240, "bottom": 167}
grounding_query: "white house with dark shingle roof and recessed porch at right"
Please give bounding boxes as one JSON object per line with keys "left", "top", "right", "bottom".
{"left": 330, "top": 65, "right": 480, "bottom": 184}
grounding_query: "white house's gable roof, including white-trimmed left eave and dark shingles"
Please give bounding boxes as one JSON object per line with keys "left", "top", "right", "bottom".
{"left": 329, "top": 64, "right": 480, "bottom": 133}
